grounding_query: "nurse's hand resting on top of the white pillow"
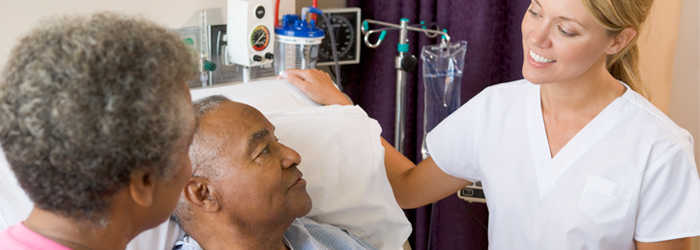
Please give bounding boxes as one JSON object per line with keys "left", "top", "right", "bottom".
{"left": 277, "top": 69, "right": 352, "bottom": 105}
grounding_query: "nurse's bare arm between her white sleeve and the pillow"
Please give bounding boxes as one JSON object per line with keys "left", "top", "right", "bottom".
{"left": 382, "top": 138, "right": 470, "bottom": 209}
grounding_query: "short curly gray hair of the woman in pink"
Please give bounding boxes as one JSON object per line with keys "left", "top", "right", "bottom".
{"left": 0, "top": 13, "right": 195, "bottom": 222}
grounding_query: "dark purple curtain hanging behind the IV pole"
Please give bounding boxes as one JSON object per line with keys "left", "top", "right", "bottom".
{"left": 342, "top": 0, "right": 530, "bottom": 250}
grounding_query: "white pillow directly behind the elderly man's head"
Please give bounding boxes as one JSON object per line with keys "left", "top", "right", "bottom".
{"left": 265, "top": 106, "right": 411, "bottom": 250}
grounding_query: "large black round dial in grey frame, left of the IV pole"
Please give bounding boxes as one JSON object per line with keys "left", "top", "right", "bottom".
{"left": 318, "top": 15, "right": 356, "bottom": 61}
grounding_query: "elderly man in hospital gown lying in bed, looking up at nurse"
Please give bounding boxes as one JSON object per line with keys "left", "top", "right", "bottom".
{"left": 174, "top": 96, "right": 374, "bottom": 250}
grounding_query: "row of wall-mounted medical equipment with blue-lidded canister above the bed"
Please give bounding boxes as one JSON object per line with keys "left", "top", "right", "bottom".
{"left": 175, "top": 0, "right": 360, "bottom": 90}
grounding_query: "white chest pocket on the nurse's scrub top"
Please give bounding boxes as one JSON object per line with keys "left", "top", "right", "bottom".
{"left": 578, "top": 175, "right": 634, "bottom": 224}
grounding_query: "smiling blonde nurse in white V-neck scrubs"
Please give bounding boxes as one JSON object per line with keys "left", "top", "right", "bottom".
{"left": 287, "top": 0, "right": 700, "bottom": 249}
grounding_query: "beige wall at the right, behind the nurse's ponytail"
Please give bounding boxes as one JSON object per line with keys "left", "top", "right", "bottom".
{"left": 652, "top": 0, "right": 700, "bottom": 250}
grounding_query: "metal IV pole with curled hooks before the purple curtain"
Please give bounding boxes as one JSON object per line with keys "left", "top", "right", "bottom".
{"left": 362, "top": 18, "right": 450, "bottom": 154}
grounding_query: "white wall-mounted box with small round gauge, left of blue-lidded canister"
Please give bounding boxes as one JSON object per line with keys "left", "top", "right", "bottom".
{"left": 225, "top": 0, "right": 277, "bottom": 67}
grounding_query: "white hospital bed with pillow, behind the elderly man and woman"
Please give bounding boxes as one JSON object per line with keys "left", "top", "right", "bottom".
{"left": 0, "top": 80, "right": 411, "bottom": 250}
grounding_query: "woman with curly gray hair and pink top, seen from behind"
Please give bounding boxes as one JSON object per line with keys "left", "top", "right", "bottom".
{"left": 0, "top": 13, "right": 195, "bottom": 249}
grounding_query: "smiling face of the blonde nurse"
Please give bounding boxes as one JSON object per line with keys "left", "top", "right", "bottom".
{"left": 521, "top": 0, "right": 614, "bottom": 84}
